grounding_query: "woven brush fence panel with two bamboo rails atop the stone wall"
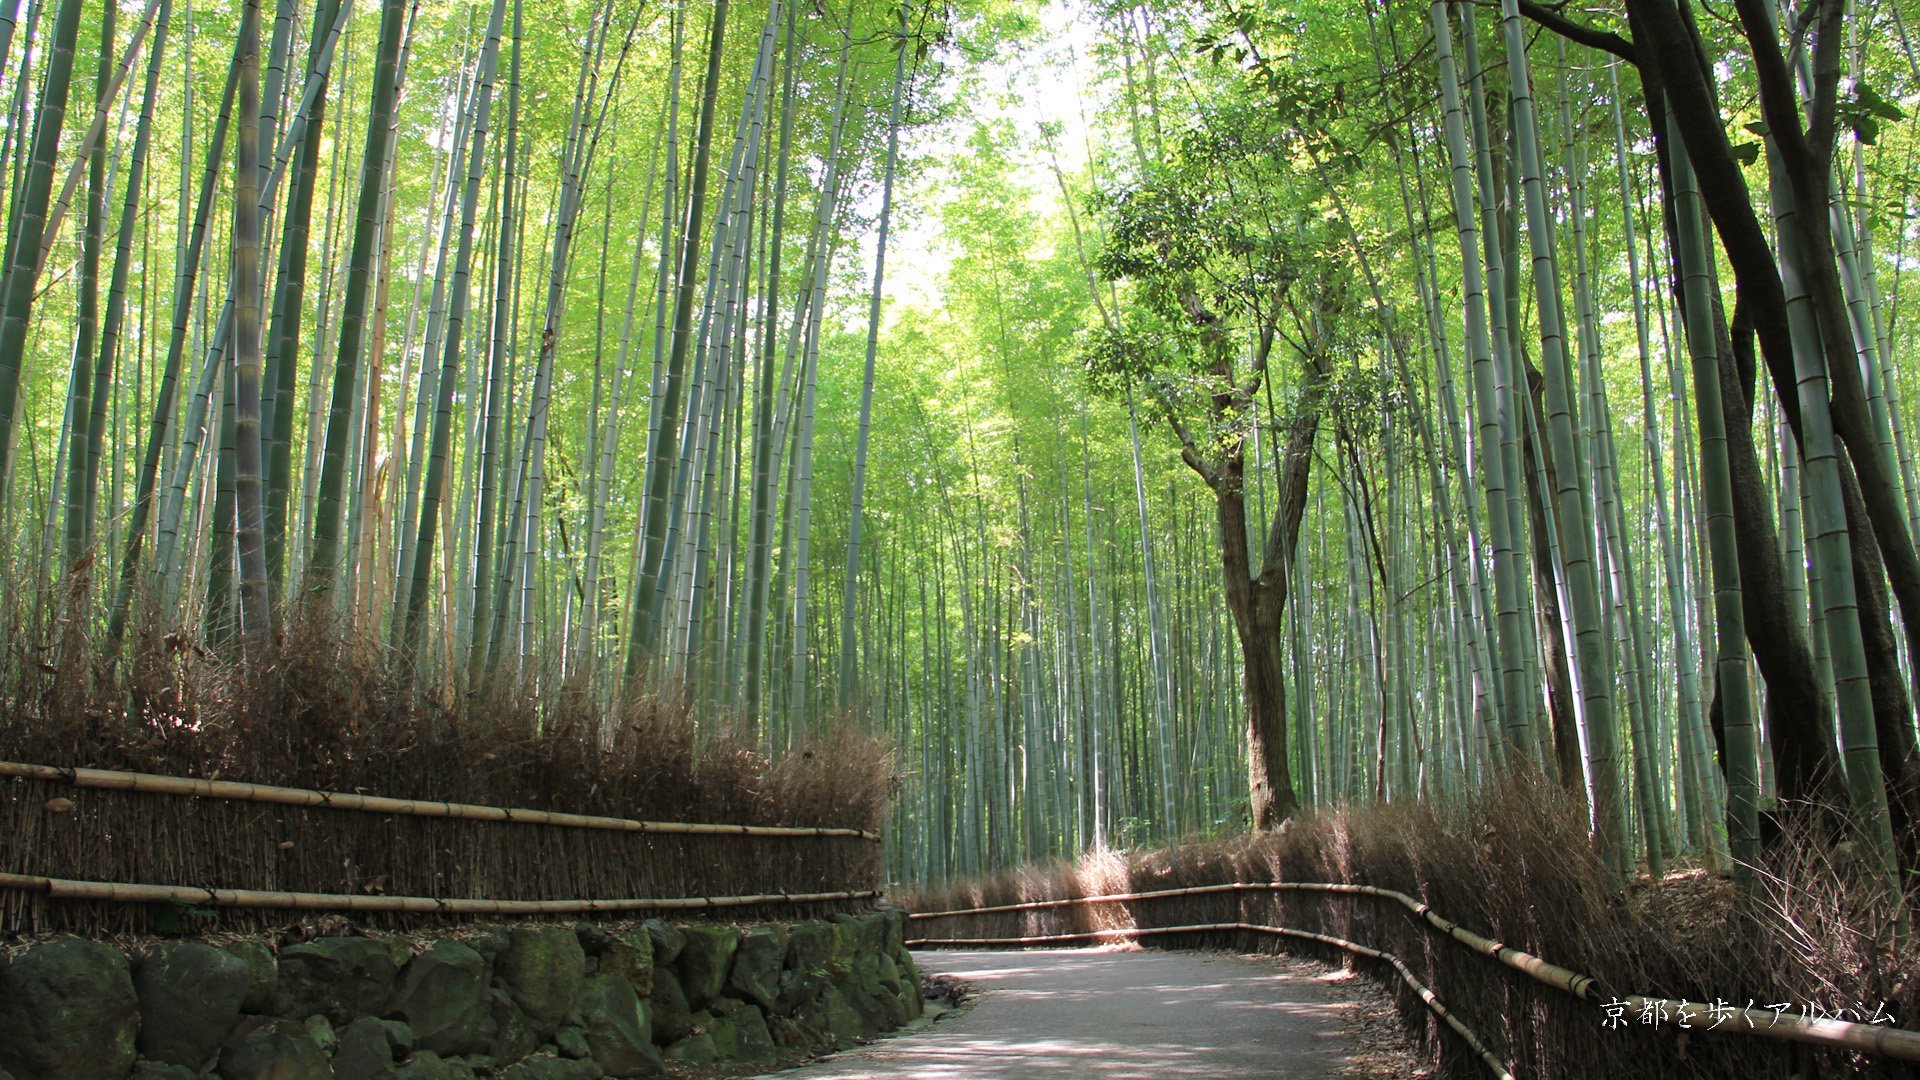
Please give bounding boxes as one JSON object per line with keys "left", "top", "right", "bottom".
{"left": 0, "top": 763, "right": 881, "bottom": 936}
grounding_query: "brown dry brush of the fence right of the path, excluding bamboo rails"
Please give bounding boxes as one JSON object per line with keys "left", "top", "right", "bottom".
{"left": 900, "top": 782, "right": 1920, "bottom": 1080}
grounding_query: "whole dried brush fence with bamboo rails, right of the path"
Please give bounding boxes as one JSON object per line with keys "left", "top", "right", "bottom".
{"left": 899, "top": 786, "right": 1920, "bottom": 1080}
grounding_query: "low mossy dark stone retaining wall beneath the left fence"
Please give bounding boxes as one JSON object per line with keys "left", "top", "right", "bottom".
{"left": 0, "top": 907, "right": 920, "bottom": 1080}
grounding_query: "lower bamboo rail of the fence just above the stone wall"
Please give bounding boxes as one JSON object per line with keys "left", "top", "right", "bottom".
{"left": 0, "top": 874, "right": 879, "bottom": 915}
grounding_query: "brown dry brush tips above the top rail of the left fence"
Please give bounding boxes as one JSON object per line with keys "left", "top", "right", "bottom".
{"left": 0, "top": 582, "right": 895, "bottom": 828}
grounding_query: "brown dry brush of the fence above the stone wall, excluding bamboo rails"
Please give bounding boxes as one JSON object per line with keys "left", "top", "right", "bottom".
{"left": 0, "top": 598, "right": 895, "bottom": 934}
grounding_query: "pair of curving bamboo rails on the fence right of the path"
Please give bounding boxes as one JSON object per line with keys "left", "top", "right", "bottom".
{"left": 906, "top": 882, "right": 1920, "bottom": 1076}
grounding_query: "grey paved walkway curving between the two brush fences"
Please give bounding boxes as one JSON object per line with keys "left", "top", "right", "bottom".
{"left": 785, "top": 949, "right": 1348, "bottom": 1080}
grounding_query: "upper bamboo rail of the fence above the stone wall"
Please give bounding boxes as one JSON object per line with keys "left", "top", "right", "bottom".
{"left": 0, "top": 761, "right": 879, "bottom": 844}
